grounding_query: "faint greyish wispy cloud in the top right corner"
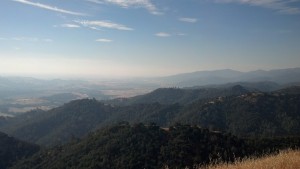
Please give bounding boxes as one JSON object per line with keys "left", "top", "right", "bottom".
{"left": 215, "top": 0, "right": 300, "bottom": 14}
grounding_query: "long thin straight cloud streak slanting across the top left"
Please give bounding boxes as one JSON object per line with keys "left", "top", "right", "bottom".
{"left": 12, "top": 0, "right": 86, "bottom": 16}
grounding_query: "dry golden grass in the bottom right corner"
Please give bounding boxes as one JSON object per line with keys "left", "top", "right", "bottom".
{"left": 207, "top": 150, "right": 300, "bottom": 169}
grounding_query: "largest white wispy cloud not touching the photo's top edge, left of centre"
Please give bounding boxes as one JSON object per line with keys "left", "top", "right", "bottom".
{"left": 74, "top": 20, "right": 133, "bottom": 31}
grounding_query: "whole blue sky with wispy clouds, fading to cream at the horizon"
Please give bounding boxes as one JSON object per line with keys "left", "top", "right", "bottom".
{"left": 0, "top": 0, "right": 300, "bottom": 78}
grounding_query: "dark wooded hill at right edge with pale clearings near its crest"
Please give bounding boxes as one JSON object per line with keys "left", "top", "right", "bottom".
{"left": 174, "top": 92, "right": 300, "bottom": 137}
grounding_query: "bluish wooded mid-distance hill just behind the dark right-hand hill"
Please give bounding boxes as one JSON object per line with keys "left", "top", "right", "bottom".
{"left": 107, "top": 85, "right": 254, "bottom": 105}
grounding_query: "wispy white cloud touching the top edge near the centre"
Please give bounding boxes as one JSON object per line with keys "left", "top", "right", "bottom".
{"left": 86, "top": 0, "right": 162, "bottom": 15}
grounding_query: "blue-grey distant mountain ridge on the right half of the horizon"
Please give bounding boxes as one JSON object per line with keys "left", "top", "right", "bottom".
{"left": 155, "top": 68, "right": 300, "bottom": 87}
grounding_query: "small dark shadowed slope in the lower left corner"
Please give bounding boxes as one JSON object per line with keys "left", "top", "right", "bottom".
{"left": 0, "top": 132, "right": 39, "bottom": 169}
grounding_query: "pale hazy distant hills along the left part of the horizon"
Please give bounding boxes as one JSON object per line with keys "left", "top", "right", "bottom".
{"left": 0, "top": 76, "right": 109, "bottom": 99}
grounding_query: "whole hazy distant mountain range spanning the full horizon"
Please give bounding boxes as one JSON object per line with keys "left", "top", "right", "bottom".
{"left": 0, "top": 68, "right": 300, "bottom": 99}
